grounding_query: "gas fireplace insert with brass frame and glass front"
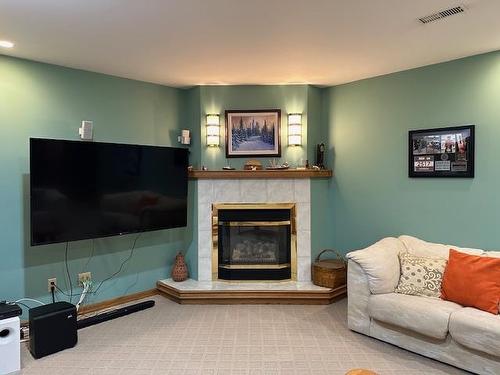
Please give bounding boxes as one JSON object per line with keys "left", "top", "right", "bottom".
{"left": 212, "top": 203, "right": 297, "bottom": 281}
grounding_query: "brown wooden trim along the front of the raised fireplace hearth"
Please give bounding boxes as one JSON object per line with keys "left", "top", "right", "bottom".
{"left": 156, "top": 282, "right": 347, "bottom": 305}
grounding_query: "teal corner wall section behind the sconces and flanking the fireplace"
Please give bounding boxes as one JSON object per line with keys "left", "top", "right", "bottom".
{"left": 187, "top": 85, "right": 331, "bottom": 268}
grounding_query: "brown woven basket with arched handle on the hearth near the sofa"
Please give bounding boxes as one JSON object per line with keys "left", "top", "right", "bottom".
{"left": 311, "top": 249, "right": 347, "bottom": 289}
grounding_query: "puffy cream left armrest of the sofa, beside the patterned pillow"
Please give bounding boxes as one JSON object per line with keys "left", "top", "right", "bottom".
{"left": 347, "top": 237, "right": 405, "bottom": 294}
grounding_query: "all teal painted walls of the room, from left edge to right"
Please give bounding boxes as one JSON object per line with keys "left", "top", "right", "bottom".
{"left": 0, "top": 47, "right": 500, "bottom": 308}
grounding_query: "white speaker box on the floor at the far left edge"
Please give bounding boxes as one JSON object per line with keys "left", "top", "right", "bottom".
{"left": 0, "top": 316, "right": 21, "bottom": 375}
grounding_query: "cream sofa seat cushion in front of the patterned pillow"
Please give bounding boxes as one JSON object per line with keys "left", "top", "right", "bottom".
{"left": 368, "top": 293, "right": 462, "bottom": 339}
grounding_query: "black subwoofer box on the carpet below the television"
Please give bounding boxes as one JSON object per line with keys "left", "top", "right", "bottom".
{"left": 29, "top": 302, "right": 78, "bottom": 358}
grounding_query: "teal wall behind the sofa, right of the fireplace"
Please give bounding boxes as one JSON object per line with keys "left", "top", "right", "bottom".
{"left": 323, "top": 52, "right": 500, "bottom": 251}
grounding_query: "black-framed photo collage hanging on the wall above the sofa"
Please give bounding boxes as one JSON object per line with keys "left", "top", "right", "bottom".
{"left": 408, "top": 125, "right": 475, "bottom": 178}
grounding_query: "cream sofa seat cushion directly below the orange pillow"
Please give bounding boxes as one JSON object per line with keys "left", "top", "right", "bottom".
{"left": 450, "top": 307, "right": 500, "bottom": 357}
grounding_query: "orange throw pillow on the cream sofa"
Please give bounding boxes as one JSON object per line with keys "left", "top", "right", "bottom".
{"left": 441, "top": 249, "right": 500, "bottom": 314}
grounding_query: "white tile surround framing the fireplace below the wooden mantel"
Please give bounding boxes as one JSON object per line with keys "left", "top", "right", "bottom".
{"left": 198, "top": 178, "right": 311, "bottom": 282}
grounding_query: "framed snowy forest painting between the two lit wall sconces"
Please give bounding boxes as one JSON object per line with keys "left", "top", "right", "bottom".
{"left": 226, "top": 109, "right": 281, "bottom": 158}
